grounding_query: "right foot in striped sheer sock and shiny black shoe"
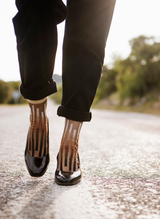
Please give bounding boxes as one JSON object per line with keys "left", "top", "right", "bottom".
{"left": 55, "top": 119, "right": 82, "bottom": 185}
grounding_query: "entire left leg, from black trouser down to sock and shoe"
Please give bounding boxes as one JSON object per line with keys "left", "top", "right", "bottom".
{"left": 13, "top": 0, "right": 67, "bottom": 176}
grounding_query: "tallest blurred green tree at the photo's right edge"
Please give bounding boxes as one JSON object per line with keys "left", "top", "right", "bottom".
{"left": 114, "top": 36, "right": 160, "bottom": 100}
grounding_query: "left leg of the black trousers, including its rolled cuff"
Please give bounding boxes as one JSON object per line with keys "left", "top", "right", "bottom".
{"left": 13, "top": 0, "right": 67, "bottom": 100}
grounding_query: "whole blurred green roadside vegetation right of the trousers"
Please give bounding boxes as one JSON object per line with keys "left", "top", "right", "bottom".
{"left": 94, "top": 36, "right": 160, "bottom": 114}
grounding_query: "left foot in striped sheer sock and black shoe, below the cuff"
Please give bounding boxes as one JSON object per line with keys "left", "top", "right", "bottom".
{"left": 25, "top": 100, "right": 49, "bottom": 177}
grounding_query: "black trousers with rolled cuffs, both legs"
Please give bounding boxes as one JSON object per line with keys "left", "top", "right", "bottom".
{"left": 13, "top": 0, "right": 116, "bottom": 121}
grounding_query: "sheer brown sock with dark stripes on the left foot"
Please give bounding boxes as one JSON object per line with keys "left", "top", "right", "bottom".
{"left": 27, "top": 98, "right": 49, "bottom": 157}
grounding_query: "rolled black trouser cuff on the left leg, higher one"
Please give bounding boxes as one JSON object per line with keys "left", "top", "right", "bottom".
{"left": 20, "top": 81, "right": 57, "bottom": 100}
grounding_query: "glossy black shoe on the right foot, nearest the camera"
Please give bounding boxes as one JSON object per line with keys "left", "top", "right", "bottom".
{"left": 55, "top": 155, "right": 82, "bottom": 186}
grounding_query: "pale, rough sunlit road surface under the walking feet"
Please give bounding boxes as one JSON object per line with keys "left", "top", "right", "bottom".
{"left": 0, "top": 102, "right": 160, "bottom": 219}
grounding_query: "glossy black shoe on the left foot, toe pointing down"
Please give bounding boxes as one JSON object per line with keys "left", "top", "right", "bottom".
{"left": 24, "top": 117, "right": 50, "bottom": 177}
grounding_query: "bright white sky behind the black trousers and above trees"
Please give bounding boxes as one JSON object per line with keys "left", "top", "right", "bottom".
{"left": 0, "top": 0, "right": 160, "bottom": 81}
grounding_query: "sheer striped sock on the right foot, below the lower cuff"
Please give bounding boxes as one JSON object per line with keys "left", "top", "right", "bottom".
{"left": 57, "top": 119, "right": 83, "bottom": 172}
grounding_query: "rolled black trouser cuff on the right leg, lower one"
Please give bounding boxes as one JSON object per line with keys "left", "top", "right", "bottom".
{"left": 57, "top": 106, "right": 92, "bottom": 122}
